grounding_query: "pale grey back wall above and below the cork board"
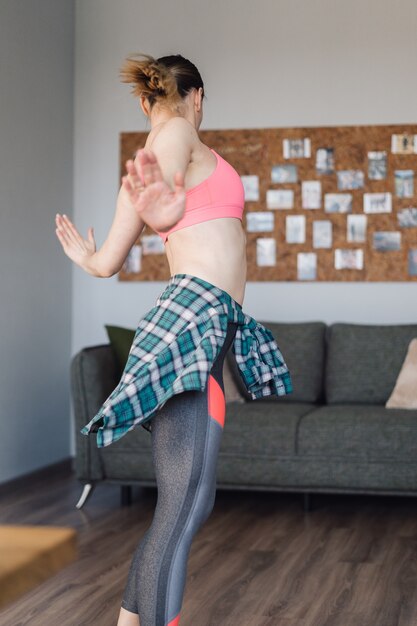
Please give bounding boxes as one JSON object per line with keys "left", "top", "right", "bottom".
{"left": 72, "top": 0, "right": 417, "bottom": 352}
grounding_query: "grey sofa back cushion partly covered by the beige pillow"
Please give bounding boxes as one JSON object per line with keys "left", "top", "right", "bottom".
{"left": 325, "top": 323, "right": 417, "bottom": 405}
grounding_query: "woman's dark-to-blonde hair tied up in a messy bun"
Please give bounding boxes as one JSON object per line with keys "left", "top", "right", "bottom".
{"left": 120, "top": 53, "right": 204, "bottom": 108}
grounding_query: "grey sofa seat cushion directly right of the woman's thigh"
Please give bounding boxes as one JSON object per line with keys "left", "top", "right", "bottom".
{"left": 220, "top": 398, "right": 317, "bottom": 459}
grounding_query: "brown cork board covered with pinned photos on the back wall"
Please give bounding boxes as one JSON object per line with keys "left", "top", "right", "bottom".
{"left": 119, "top": 124, "right": 417, "bottom": 281}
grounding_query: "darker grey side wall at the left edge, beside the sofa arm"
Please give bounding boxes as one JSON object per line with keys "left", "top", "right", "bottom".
{"left": 0, "top": 0, "right": 74, "bottom": 482}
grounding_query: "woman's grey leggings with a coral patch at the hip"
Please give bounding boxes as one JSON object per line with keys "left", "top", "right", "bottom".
{"left": 121, "top": 321, "right": 237, "bottom": 626}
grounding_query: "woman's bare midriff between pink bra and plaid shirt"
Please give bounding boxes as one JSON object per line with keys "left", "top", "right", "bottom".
{"left": 165, "top": 217, "right": 246, "bottom": 306}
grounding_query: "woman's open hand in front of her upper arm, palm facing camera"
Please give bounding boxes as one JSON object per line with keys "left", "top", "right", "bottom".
{"left": 122, "top": 149, "right": 186, "bottom": 232}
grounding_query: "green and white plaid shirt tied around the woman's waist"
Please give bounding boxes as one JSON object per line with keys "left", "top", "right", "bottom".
{"left": 80, "top": 274, "right": 293, "bottom": 448}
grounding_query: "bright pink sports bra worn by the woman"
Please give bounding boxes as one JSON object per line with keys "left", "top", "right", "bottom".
{"left": 155, "top": 148, "right": 245, "bottom": 243}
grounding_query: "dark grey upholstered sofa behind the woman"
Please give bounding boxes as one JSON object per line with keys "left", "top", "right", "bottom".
{"left": 71, "top": 320, "right": 417, "bottom": 509}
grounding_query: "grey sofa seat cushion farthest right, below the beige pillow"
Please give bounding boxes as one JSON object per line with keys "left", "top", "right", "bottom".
{"left": 296, "top": 404, "right": 417, "bottom": 463}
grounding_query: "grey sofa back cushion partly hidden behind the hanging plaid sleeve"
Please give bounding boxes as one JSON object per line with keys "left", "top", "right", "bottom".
{"left": 227, "top": 321, "right": 327, "bottom": 403}
